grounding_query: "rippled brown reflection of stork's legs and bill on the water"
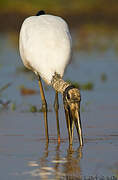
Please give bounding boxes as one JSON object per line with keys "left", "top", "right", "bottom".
{"left": 23, "top": 144, "right": 82, "bottom": 179}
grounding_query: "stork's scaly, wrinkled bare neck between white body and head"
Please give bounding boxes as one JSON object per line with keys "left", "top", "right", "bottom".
{"left": 51, "top": 73, "right": 70, "bottom": 94}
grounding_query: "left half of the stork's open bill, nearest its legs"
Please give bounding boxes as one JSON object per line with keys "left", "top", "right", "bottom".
{"left": 64, "top": 105, "right": 74, "bottom": 145}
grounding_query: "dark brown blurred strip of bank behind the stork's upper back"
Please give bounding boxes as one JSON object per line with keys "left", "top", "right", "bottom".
{"left": 0, "top": 12, "right": 118, "bottom": 32}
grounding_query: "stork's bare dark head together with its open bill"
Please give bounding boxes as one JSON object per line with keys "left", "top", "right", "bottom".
{"left": 63, "top": 85, "right": 83, "bottom": 145}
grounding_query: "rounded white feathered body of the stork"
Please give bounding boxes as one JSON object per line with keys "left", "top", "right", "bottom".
{"left": 19, "top": 14, "right": 71, "bottom": 84}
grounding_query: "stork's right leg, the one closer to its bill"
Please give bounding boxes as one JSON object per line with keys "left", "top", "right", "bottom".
{"left": 54, "top": 91, "right": 60, "bottom": 143}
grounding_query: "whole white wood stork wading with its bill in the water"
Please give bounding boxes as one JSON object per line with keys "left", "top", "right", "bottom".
{"left": 19, "top": 11, "right": 83, "bottom": 146}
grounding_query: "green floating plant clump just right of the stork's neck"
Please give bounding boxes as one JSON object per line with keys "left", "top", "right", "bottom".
{"left": 67, "top": 80, "right": 94, "bottom": 91}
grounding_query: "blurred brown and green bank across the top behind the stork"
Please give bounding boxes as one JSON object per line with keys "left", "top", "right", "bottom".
{"left": 0, "top": 0, "right": 118, "bottom": 51}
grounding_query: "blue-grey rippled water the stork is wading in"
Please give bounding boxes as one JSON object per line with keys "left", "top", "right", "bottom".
{"left": 0, "top": 30, "right": 118, "bottom": 180}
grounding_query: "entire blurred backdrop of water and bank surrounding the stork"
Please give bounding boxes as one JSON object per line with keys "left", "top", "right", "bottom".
{"left": 0, "top": 0, "right": 118, "bottom": 180}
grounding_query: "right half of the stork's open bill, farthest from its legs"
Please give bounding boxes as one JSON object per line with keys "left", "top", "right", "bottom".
{"left": 71, "top": 105, "right": 83, "bottom": 146}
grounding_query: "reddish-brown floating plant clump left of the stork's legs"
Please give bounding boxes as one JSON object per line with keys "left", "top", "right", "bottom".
{"left": 20, "top": 86, "right": 38, "bottom": 96}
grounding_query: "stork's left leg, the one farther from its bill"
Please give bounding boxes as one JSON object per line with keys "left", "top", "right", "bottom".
{"left": 38, "top": 75, "right": 49, "bottom": 141}
